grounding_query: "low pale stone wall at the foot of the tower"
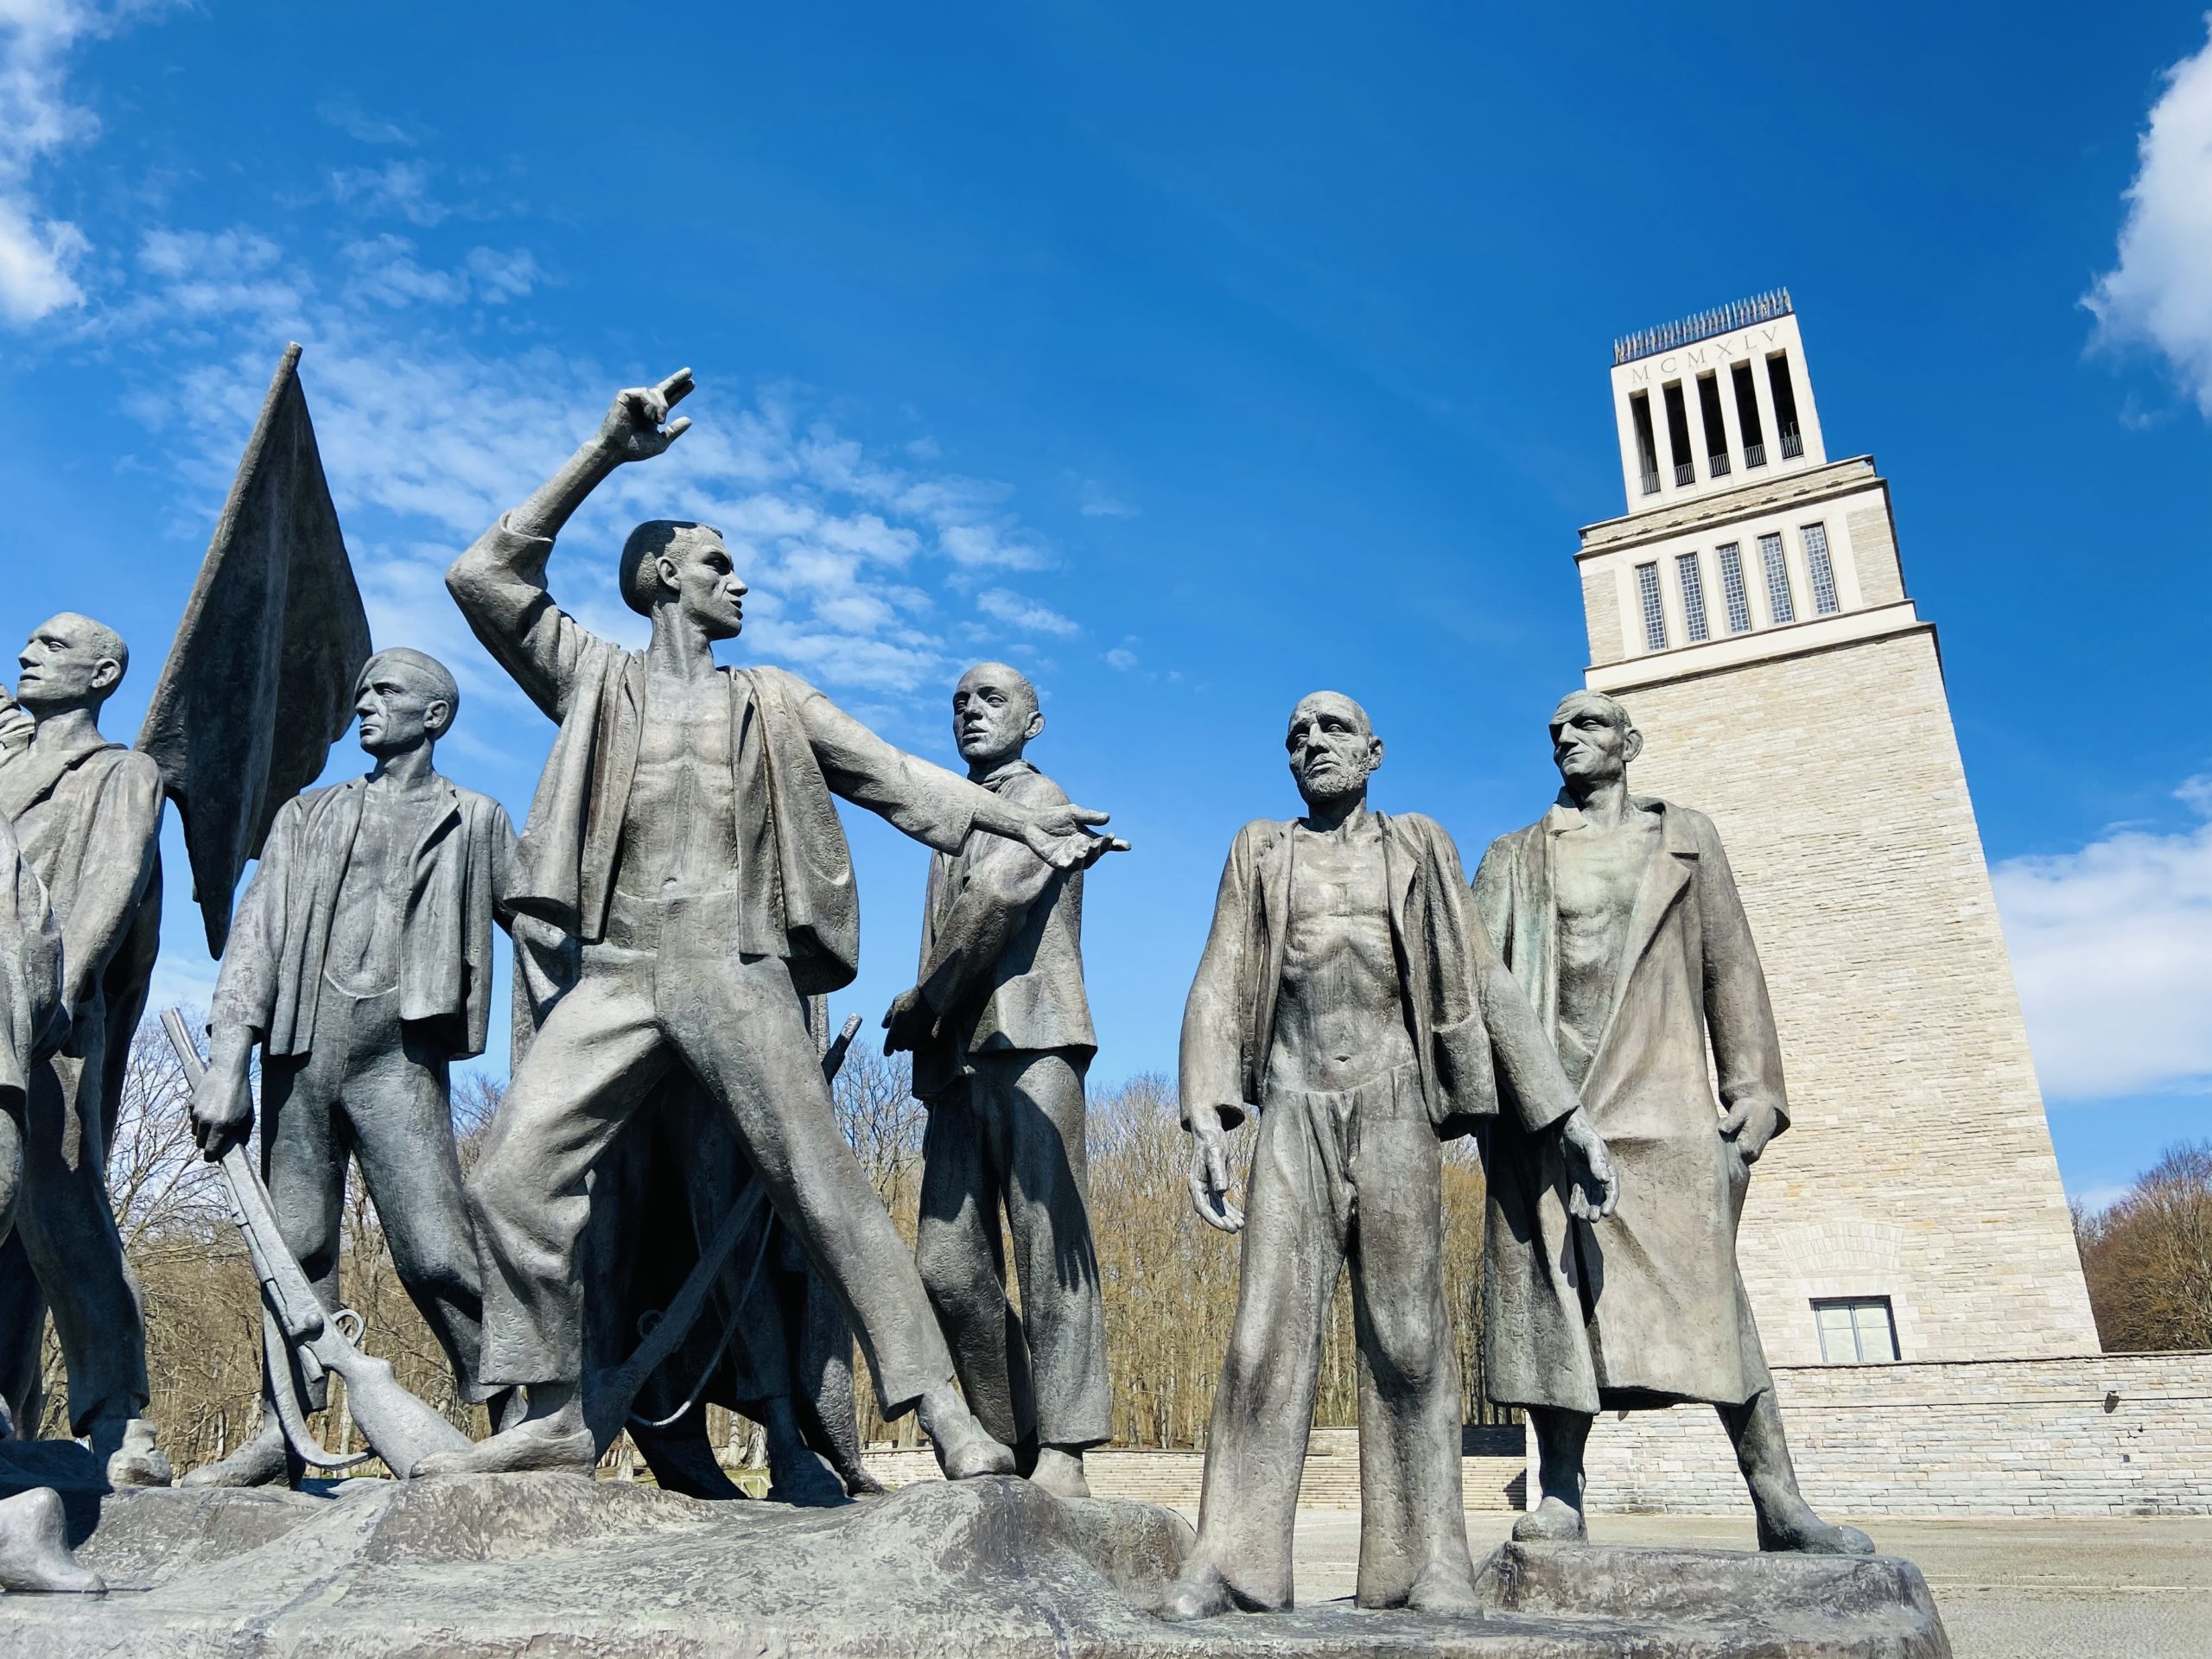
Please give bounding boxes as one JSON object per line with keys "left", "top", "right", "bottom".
{"left": 1574, "top": 1354, "right": 2212, "bottom": 1517}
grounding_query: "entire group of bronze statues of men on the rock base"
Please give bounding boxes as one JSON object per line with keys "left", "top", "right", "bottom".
{"left": 0, "top": 373, "right": 1872, "bottom": 1619}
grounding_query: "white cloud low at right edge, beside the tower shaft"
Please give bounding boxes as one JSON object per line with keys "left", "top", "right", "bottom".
{"left": 1991, "top": 774, "right": 2212, "bottom": 1099}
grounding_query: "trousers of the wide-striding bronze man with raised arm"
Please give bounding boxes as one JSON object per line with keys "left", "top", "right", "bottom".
{"left": 471, "top": 938, "right": 953, "bottom": 1415}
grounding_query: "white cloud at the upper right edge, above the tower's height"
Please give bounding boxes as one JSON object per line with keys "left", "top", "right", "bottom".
{"left": 2082, "top": 20, "right": 2212, "bottom": 416}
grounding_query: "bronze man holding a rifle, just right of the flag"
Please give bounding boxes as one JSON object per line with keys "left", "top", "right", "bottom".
{"left": 186, "top": 648, "right": 515, "bottom": 1486}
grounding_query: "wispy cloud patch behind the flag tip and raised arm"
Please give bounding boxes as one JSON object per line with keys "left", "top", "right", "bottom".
{"left": 104, "top": 215, "right": 1075, "bottom": 703}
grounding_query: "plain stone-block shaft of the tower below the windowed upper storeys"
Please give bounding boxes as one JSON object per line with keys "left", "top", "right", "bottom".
{"left": 1619, "top": 624, "right": 2097, "bottom": 1365}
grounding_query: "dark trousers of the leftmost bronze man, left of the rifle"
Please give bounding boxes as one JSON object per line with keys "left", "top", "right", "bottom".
{"left": 16, "top": 1020, "right": 150, "bottom": 1433}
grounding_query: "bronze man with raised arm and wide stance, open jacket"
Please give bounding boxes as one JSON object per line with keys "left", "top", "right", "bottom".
{"left": 420, "top": 370, "right": 1117, "bottom": 1478}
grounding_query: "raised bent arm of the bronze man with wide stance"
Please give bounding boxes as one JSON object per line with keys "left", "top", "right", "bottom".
{"left": 445, "top": 370, "right": 692, "bottom": 719}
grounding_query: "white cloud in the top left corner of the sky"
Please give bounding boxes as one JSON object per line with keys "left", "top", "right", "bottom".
{"left": 0, "top": 0, "right": 168, "bottom": 327}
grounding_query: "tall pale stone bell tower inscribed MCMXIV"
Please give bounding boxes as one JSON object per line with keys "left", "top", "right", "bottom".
{"left": 1575, "top": 289, "right": 2097, "bottom": 1365}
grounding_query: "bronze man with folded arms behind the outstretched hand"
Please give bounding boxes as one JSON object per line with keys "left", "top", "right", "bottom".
{"left": 882, "top": 661, "right": 1113, "bottom": 1497}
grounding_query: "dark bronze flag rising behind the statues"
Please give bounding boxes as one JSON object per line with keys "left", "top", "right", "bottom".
{"left": 137, "top": 345, "right": 370, "bottom": 956}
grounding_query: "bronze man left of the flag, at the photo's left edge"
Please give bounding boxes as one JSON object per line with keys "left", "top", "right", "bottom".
{"left": 0, "top": 611, "right": 170, "bottom": 1486}
